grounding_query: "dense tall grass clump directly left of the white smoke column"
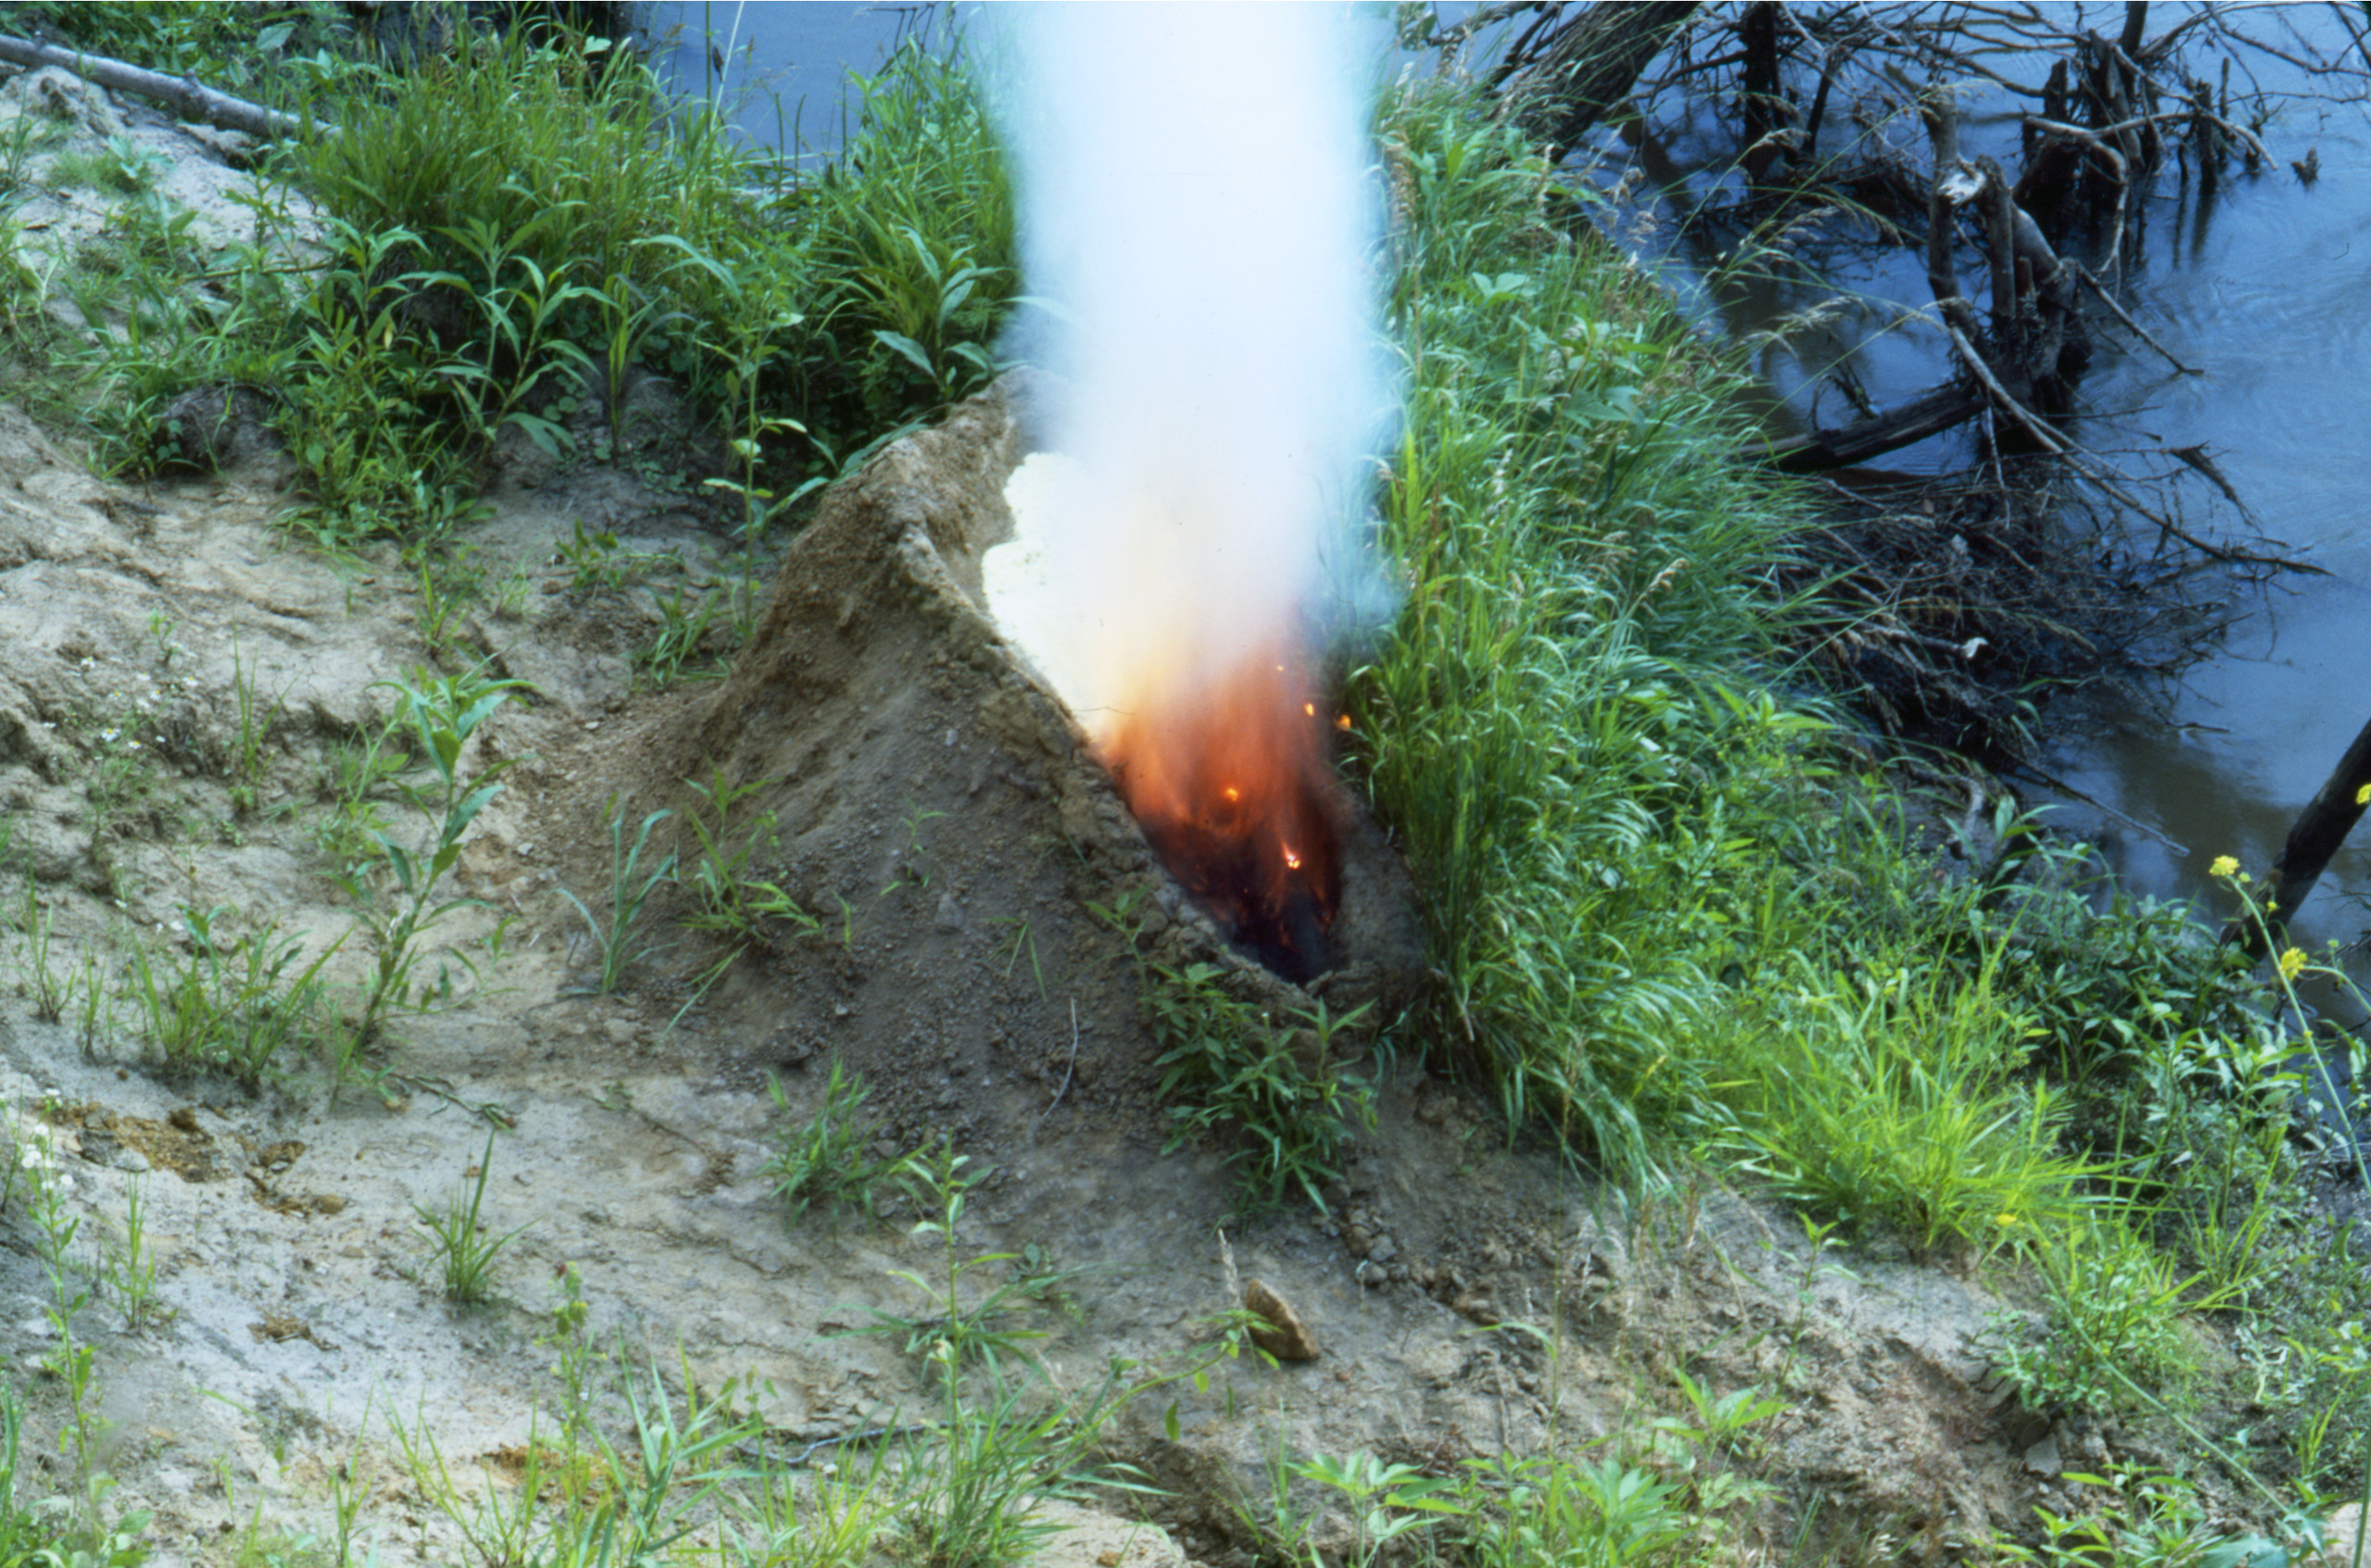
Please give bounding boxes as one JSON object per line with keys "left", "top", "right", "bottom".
{"left": 284, "top": 33, "right": 1017, "bottom": 526}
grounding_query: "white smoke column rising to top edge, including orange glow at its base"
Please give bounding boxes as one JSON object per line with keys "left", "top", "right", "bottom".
{"left": 998, "top": 5, "right": 1387, "bottom": 968}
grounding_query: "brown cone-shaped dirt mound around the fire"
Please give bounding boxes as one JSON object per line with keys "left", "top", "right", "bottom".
{"left": 559, "top": 377, "right": 1425, "bottom": 1150}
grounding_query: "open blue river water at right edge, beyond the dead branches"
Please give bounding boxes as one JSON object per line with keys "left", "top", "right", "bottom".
{"left": 2049, "top": 79, "right": 2371, "bottom": 942}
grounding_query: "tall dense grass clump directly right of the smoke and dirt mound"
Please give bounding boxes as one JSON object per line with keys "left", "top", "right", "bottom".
{"left": 1349, "top": 90, "right": 1819, "bottom": 1172}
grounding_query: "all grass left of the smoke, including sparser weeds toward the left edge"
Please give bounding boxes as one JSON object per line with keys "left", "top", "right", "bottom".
{"left": 55, "top": 24, "right": 1020, "bottom": 558}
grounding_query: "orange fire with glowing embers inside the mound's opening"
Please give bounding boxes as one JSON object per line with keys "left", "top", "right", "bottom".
{"left": 1096, "top": 652, "right": 1342, "bottom": 980}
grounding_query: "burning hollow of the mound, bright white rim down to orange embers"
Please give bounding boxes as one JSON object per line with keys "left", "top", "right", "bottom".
{"left": 982, "top": 453, "right": 1345, "bottom": 985}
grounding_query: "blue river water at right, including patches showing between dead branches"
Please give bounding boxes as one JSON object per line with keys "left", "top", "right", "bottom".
{"left": 1610, "top": 5, "right": 2371, "bottom": 944}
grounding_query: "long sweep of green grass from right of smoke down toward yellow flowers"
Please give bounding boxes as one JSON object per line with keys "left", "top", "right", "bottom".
{"left": 1347, "top": 88, "right": 2278, "bottom": 1252}
